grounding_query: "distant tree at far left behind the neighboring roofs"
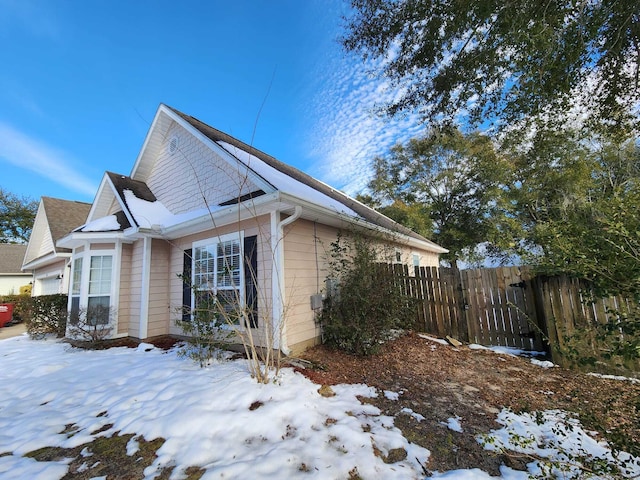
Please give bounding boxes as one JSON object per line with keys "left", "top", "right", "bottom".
{"left": 0, "top": 187, "right": 38, "bottom": 243}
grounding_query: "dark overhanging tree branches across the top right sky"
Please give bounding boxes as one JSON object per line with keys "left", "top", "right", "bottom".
{"left": 342, "top": 0, "right": 640, "bottom": 135}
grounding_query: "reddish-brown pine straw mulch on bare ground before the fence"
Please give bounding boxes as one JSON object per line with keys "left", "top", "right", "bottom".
{"left": 298, "top": 333, "right": 640, "bottom": 475}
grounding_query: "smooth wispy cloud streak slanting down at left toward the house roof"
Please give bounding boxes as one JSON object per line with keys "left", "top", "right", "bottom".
{"left": 0, "top": 122, "right": 97, "bottom": 196}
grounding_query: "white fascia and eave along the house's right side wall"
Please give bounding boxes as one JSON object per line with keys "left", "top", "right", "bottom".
{"left": 281, "top": 193, "right": 449, "bottom": 253}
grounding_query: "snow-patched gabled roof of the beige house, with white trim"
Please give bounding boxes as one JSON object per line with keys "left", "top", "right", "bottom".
{"left": 66, "top": 104, "right": 446, "bottom": 252}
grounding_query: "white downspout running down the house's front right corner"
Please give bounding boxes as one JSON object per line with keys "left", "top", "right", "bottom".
{"left": 271, "top": 206, "right": 302, "bottom": 355}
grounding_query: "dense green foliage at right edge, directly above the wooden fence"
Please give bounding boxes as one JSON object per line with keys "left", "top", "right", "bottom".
{"left": 508, "top": 132, "right": 640, "bottom": 299}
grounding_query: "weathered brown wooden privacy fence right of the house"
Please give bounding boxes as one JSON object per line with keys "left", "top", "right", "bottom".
{"left": 391, "top": 265, "right": 640, "bottom": 376}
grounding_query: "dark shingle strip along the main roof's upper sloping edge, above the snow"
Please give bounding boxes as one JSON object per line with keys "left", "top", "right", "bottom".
{"left": 167, "top": 106, "right": 435, "bottom": 245}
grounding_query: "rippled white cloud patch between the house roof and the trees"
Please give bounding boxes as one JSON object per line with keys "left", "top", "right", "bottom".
{"left": 310, "top": 55, "right": 424, "bottom": 195}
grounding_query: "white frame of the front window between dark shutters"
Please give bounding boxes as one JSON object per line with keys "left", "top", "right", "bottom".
{"left": 191, "top": 232, "right": 246, "bottom": 328}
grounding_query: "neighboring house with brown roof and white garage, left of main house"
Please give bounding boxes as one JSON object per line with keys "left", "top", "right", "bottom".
{"left": 22, "top": 197, "right": 91, "bottom": 297}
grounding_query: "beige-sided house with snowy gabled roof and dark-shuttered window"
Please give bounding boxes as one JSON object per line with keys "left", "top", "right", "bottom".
{"left": 57, "top": 105, "right": 446, "bottom": 353}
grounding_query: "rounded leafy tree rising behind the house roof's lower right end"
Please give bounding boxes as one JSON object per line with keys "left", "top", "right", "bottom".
{"left": 369, "top": 129, "right": 509, "bottom": 263}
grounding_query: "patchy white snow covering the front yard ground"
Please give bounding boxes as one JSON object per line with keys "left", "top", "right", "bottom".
{"left": 0, "top": 336, "right": 640, "bottom": 480}
